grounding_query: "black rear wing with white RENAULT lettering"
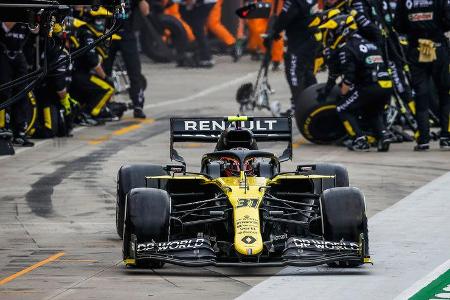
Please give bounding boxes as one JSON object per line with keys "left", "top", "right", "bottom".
{"left": 170, "top": 116, "right": 292, "bottom": 164}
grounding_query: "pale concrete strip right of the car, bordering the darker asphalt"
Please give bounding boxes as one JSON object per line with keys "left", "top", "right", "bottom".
{"left": 238, "top": 172, "right": 450, "bottom": 300}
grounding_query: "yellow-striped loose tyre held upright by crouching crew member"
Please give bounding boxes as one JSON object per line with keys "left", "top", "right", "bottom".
{"left": 295, "top": 83, "right": 346, "bottom": 144}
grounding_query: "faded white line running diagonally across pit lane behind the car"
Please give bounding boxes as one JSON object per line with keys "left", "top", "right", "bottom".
{"left": 0, "top": 72, "right": 256, "bottom": 161}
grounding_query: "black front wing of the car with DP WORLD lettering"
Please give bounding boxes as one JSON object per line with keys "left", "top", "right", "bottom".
{"left": 125, "top": 237, "right": 372, "bottom": 267}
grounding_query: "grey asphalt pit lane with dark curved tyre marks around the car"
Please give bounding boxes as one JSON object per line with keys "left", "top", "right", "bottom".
{"left": 0, "top": 58, "right": 450, "bottom": 299}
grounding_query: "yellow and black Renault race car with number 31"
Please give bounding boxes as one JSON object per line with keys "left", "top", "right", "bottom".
{"left": 116, "top": 117, "right": 371, "bottom": 268}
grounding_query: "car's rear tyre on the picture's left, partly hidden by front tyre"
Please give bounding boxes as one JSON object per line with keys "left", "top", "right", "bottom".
{"left": 116, "top": 164, "right": 167, "bottom": 238}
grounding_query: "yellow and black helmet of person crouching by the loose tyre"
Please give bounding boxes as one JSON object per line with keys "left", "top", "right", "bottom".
{"left": 319, "top": 14, "right": 358, "bottom": 49}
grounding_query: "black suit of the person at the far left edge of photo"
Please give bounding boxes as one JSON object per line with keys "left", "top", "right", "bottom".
{"left": 0, "top": 22, "right": 30, "bottom": 135}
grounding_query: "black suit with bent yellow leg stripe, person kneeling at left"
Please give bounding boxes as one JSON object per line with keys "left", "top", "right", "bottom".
{"left": 70, "top": 25, "right": 114, "bottom": 117}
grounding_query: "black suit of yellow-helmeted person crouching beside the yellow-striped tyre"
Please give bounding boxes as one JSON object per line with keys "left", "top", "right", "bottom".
{"left": 329, "top": 34, "right": 392, "bottom": 138}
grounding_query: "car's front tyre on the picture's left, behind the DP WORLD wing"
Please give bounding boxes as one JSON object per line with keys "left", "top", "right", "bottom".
{"left": 123, "top": 188, "right": 170, "bottom": 269}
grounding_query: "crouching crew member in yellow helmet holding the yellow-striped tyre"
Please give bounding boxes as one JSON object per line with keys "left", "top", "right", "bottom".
{"left": 319, "top": 14, "right": 392, "bottom": 151}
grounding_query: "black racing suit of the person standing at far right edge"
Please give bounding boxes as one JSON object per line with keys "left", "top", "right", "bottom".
{"left": 395, "top": 0, "right": 450, "bottom": 144}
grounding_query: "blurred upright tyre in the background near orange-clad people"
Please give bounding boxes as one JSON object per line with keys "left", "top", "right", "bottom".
{"left": 140, "top": 15, "right": 189, "bottom": 63}
